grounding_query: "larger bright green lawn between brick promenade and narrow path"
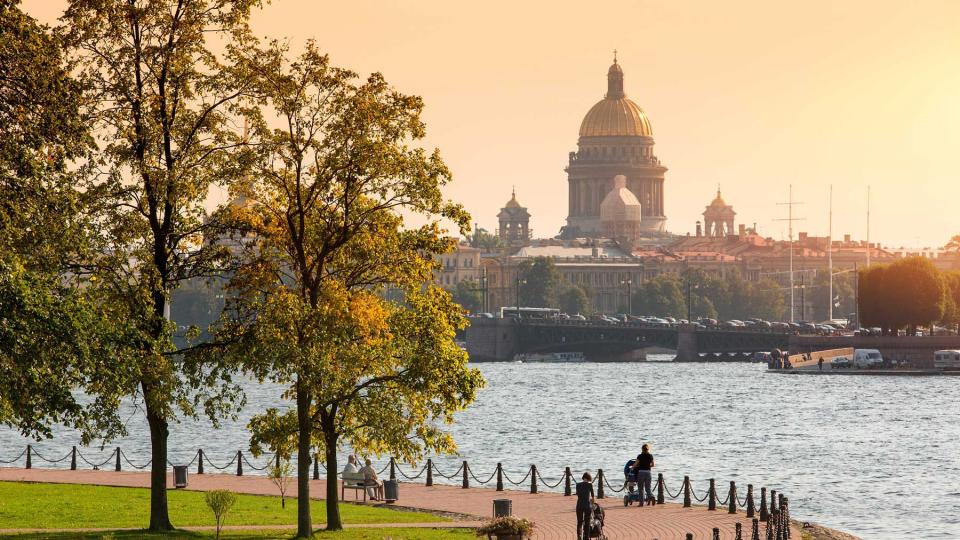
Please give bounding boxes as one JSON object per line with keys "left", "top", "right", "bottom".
{"left": 0, "top": 482, "right": 447, "bottom": 528}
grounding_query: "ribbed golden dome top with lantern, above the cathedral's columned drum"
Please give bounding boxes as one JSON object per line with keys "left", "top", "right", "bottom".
{"left": 580, "top": 60, "right": 653, "bottom": 137}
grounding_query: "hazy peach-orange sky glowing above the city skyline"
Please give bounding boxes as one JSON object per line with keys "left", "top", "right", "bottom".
{"left": 22, "top": 0, "right": 960, "bottom": 247}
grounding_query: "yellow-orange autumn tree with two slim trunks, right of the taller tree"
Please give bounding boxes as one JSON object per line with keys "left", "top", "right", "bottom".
{"left": 209, "top": 42, "right": 482, "bottom": 537}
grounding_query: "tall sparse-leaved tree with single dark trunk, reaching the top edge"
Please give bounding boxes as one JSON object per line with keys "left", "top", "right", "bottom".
{"left": 61, "top": 0, "right": 259, "bottom": 531}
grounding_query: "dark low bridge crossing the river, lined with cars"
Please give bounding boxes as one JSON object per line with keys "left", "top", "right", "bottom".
{"left": 466, "top": 318, "right": 790, "bottom": 361}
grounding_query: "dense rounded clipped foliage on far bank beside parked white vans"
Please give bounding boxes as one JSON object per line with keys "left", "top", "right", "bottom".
{"left": 860, "top": 257, "right": 951, "bottom": 332}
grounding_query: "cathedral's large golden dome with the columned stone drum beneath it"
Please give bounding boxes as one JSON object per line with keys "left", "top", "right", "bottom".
{"left": 565, "top": 57, "right": 667, "bottom": 237}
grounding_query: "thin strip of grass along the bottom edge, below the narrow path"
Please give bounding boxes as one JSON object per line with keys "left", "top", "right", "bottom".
{"left": 0, "top": 528, "right": 476, "bottom": 540}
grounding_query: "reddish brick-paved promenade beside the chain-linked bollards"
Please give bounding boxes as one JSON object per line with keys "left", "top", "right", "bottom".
{"left": 0, "top": 468, "right": 801, "bottom": 540}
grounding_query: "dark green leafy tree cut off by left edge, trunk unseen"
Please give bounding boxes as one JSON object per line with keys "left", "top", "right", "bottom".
{"left": 0, "top": 0, "right": 123, "bottom": 442}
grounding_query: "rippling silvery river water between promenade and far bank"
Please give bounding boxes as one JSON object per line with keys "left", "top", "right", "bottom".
{"left": 0, "top": 362, "right": 960, "bottom": 539}
